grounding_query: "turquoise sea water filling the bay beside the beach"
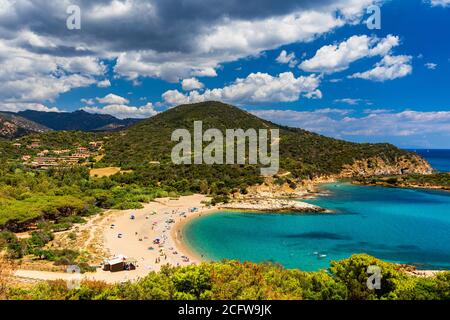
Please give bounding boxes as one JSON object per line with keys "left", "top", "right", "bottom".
{"left": 183, "top": 184, "right": 450, "bottom": 271}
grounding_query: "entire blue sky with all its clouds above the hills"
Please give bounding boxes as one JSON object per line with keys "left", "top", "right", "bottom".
{"left": 0, "top": 0, "right": 450, "bottom": 148}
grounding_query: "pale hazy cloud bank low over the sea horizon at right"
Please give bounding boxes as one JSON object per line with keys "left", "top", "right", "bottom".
{"left": 250, "top": 109, "right": 450, "bottom": 145}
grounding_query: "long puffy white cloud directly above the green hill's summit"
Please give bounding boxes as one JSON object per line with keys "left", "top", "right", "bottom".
{"left": 162, "top": 72, "right": 322, "bottom": 105}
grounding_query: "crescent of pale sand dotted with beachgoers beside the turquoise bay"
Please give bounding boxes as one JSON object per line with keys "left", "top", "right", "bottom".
{"left": 101, "top": 195, "right": 217, "bottom": 278}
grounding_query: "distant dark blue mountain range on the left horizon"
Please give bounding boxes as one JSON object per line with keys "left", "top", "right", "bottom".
{"left": 0, "top": 110, "right": 140, "bottom": 139}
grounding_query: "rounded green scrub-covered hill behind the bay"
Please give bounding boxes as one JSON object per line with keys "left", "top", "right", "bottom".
{"left": 104, "top": 102, "right": 427, "bottom": 178}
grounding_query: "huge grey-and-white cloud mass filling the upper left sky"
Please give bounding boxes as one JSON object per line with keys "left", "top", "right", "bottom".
{"left": 0, "top": 0, "right": 377, "bottom": 103}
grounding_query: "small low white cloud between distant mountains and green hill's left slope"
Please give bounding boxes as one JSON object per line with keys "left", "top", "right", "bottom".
{"left": 81, "top": 103, "right": 157, "bottom": 119}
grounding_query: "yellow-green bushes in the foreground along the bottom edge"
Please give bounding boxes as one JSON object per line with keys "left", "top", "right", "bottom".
{"left": 0, "top": 254, "right": 450, "bottom": 300}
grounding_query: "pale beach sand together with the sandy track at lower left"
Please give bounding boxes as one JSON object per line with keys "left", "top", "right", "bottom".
{"left": 15, "top": 195, "right": 218, "bottom": 283}
